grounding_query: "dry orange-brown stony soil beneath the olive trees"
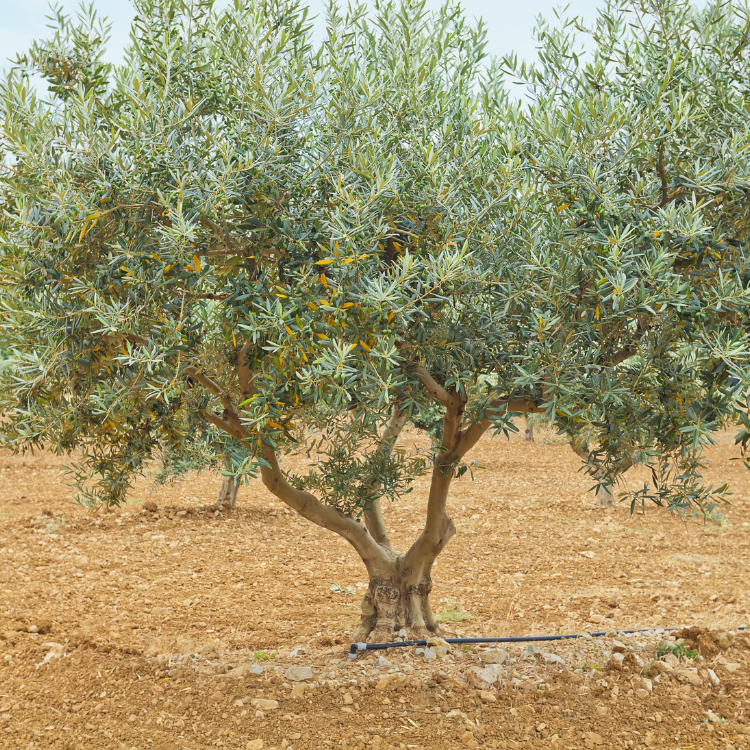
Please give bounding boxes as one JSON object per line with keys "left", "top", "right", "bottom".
{"left": 0, "top": 424, "right": 750, "bottom": 750}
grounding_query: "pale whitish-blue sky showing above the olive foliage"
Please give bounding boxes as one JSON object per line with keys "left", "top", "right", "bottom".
{"left": 0, "top": 0, "right": 612, "bottom": 74}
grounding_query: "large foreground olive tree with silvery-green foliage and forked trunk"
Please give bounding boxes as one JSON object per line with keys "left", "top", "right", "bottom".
{"left": 0, "top": 0, "right": 750, "bottom": 640}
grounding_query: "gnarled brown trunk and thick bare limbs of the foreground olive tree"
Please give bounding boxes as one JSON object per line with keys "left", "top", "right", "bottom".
{"left": 203, "top": 347, "right": 543, "bottom": 643}
